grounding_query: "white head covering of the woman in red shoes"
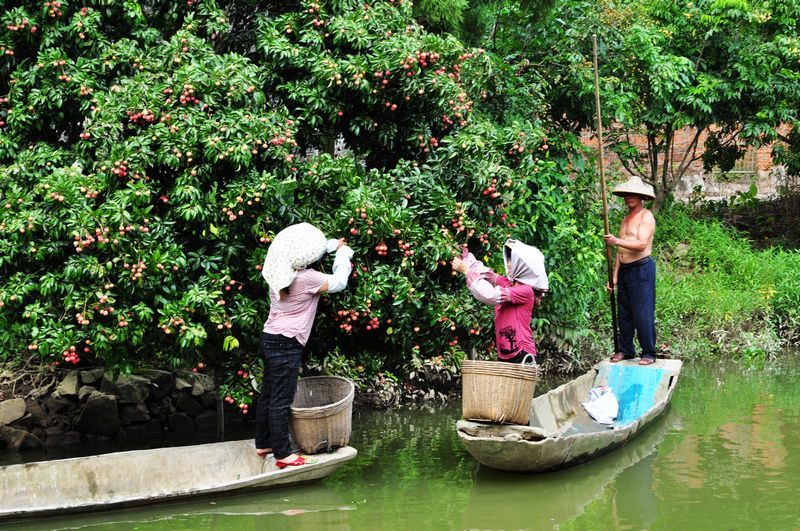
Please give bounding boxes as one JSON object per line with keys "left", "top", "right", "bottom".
{"left": 261, "top": 223, "right": 327, "bottom": 296}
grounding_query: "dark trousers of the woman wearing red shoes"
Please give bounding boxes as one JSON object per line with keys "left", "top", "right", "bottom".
{"left": 256, "top": 333, "right": 303, "bottom": 459}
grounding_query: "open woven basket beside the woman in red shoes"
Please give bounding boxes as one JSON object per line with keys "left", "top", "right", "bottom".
{"left": 289, "top": 376, "right": 355, "bottom": 454}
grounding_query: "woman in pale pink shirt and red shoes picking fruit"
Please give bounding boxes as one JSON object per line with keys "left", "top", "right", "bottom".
{"left": 256, "top": 223, "right": 353, "bottom": 468}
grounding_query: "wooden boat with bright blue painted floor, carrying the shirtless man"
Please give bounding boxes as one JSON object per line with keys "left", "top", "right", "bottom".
{"left": 456, "top": 360, "right": 682, "bottom": 472}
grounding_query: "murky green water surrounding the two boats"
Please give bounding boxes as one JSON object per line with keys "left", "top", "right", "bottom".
{"left": 6, "top": 360, "right": 800, "bottom": 531}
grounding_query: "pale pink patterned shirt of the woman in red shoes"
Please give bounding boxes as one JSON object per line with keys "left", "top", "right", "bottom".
{"left": 264, "top": 269, "right": 327, "bottom": 346}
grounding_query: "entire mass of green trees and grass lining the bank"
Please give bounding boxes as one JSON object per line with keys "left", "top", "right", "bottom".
{"left": 0, "top": 0, "right": 800, "bottom": 403}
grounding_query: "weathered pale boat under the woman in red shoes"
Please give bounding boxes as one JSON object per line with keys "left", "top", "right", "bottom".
{"left": 0, "top": 440, "right": 357, "bottom": 520}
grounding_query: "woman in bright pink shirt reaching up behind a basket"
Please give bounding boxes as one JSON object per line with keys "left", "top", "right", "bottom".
{"left": 453, "top": 239, "right": 548, "bottom": 363}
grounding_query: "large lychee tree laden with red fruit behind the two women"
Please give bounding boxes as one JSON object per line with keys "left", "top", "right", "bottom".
{"left": 0, "top": 0, "right": 601, "bottom": 405}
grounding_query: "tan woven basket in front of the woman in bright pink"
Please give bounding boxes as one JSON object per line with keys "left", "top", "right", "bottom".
{"left": 461, "top": 360, "right": 539, "bottom": 425}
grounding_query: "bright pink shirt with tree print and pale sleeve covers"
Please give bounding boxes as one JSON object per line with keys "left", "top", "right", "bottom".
{"left": 467, "top": 269, "right": 537, "bottom": 360}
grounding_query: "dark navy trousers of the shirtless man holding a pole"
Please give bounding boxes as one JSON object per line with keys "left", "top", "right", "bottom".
{"left": 617, "top": 256, "right": 656, "bottom": 358}
